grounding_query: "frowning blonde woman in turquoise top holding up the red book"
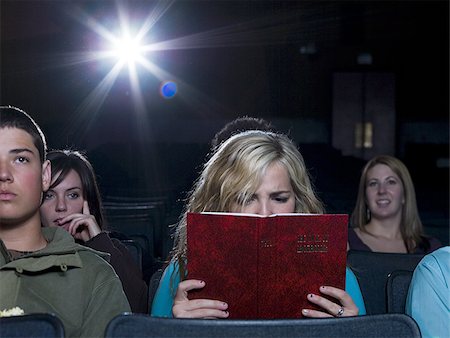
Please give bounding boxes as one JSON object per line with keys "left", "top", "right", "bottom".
{"left": 151, "top": 130, "right": 365, "bottom": 318}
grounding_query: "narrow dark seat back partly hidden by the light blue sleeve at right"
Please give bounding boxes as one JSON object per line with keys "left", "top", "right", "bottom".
{"left": 386, "top": 270, "right": 413, "bottom": 313}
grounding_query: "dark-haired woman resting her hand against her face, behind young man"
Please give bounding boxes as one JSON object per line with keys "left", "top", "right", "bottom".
{"left": 41, "top": 150, "right": 148, "bottom": 313}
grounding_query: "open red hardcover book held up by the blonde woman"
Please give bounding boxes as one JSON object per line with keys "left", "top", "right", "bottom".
{"left": 187, "top": 213, "right": 348, "bottom": 319}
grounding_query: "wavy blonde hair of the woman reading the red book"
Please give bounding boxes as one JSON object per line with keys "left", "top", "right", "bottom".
{"left": 171, "top": 130, "right": 324, "bottom": 279}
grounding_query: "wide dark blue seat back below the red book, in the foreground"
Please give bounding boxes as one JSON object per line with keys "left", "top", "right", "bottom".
{"left": 105, "top": 314, "right": 421, "bottom": 338}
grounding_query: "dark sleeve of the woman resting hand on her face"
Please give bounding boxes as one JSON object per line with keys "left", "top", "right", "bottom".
{"left": 84, "top": 232, "right": 148, "bottom": 313}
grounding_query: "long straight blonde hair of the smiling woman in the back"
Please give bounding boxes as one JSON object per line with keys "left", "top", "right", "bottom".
{"left": 350, "top": 155, "right": 423, "bottom": 252}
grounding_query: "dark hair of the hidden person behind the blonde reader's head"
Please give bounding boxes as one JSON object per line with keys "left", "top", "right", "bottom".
{"left": 211, "top": 116, "right": 275, "bottom": 151}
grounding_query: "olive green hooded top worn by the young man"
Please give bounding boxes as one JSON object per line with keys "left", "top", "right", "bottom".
{"left": 0, "top": 228, "right": 130, "bottom": 337}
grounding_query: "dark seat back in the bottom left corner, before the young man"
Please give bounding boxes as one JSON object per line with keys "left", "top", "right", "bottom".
{"left": 0, "top": 313, "right": 65, "bottom": 338}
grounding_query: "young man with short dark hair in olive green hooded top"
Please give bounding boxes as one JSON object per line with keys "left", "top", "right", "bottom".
{"left": 0, "top": 107, "right": 130, "bottom": 337}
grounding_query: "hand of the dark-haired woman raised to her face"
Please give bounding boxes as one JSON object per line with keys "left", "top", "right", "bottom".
{"left": 60, "top": 201, "right": 102, "bottom": 242}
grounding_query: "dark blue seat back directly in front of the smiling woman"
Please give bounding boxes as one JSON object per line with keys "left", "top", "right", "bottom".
{"left": 347, "top": 250, "right": 424, "bottom": 314}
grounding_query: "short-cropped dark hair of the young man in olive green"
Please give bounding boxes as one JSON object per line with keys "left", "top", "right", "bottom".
{"left": 0, "top": 106, "right": 47, "bottom": 163}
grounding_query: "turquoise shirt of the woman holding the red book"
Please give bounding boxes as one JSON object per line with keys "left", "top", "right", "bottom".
{"left": 151, "top": 262, "right": 366, "bottom": 317}
